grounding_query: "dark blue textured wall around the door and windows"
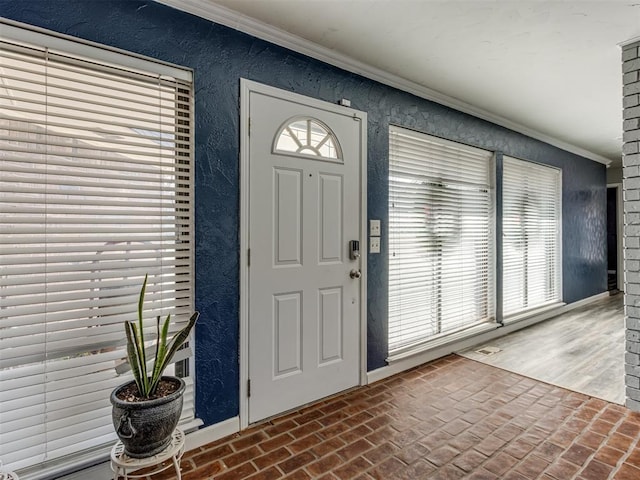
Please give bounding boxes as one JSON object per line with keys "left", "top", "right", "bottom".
{"left": 0, "top": 0, "right": 606, "bottom": 425}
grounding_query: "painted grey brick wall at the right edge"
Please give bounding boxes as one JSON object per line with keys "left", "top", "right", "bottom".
{"left": 622, "top": 41, "right": 640, "bottom": 411}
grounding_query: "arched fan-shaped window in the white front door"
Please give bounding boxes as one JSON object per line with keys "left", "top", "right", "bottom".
{"left": 274, "top": 118, "right": 342, "bottom": 162}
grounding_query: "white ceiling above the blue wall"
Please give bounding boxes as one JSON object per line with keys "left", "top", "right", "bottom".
{"left": 161, "top": 0, "right": 640, "bottom": 166}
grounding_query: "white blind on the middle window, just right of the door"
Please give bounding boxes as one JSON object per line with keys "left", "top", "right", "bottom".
{"left": 389, "top": 126, "right": 494, "bottom": 353}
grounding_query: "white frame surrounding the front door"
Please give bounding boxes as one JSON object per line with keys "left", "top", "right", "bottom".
{"left": 239, "top": 78, "right": 368, "bottom": 429}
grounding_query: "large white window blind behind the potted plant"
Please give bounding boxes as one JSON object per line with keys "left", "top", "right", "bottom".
{"left": 0, "top": 34, "right": 194, "bottom": 470}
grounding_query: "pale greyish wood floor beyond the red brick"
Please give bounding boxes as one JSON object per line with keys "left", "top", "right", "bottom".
{"left": 460, "top": 294, "right": 625, "bottom": 404}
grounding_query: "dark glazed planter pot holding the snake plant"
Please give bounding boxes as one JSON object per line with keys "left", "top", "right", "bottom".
{"left": 111, "top": 377, "right": 185, "bottom": 458}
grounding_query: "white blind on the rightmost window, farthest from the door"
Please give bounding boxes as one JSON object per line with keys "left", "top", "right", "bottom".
{"left": 502, "top": 157, "right": 562, "bottom": 317}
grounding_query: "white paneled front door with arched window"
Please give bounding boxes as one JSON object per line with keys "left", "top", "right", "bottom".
{"left": 248, "top": 84, "right": 366, "bottom": 422}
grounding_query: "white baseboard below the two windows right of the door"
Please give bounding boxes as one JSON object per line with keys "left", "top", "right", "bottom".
{"left": 367, "top": 292, "right": 609, "bottom": 384}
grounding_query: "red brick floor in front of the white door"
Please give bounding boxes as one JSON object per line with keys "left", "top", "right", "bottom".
{"left": 138, "top": 355, "right": 640, "bottom": 480}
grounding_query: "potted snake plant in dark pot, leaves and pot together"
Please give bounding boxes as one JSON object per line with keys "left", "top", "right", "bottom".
{"left": 111, "top": 276, "right": 199, "bottom": 458}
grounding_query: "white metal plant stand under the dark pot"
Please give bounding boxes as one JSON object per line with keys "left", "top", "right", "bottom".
{"left": 111, "top": 428, "right": 184, "bottom": 480}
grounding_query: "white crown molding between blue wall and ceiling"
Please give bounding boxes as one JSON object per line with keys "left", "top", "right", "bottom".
{"left": 156, "top": 0, "right": 611, "bottom": 165}
